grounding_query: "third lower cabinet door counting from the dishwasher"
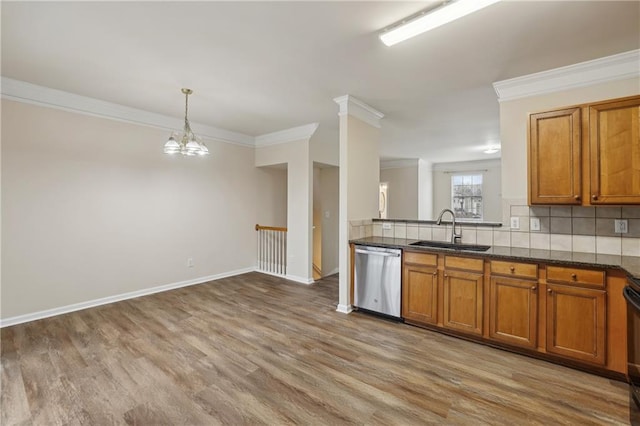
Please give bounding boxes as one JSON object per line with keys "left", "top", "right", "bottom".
{"left": 489, "top": 277, "right": 538, "bottom": 348}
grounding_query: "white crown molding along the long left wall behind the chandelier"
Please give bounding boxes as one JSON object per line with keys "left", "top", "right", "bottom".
{"left": 1, "top": 77, "right": 255, "bottom": 147}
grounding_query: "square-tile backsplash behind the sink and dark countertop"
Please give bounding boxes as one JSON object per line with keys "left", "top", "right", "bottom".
{"left": 356, "top": 200, "right": 640, "bottom": 256}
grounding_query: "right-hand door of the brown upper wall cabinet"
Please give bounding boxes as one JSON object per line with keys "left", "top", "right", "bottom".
{"left": 589, "top": 97, "right": 640, "bottom": 204}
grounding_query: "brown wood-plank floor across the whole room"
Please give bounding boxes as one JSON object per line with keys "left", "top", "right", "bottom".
{"left": 0, "top": 273, "right": 631, "bottom": 425}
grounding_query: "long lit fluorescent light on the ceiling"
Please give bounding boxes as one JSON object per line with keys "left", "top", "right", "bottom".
{"left": 380, "top": 0, "right": 500, "bottom": 46}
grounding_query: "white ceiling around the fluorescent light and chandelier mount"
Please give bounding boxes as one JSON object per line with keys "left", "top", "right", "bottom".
{"left": 1, "top": 1, "right": 640, "bottom": 163}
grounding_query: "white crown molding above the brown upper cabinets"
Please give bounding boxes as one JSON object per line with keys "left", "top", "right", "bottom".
{"left": 493, "top": 50, "right": 640, "bottom": 102}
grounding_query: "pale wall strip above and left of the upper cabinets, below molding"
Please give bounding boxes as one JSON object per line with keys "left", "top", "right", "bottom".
{"left": 500, "top": 78, "right": 640, "bottom": 203}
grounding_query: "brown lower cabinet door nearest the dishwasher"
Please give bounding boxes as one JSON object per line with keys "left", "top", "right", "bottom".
{"left": 402, "top": 265, "right": 438, "bottom": 324}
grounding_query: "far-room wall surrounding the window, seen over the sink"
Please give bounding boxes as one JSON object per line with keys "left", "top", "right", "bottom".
{"left": 433, "top": 159, "right": 502, "bottom": 222}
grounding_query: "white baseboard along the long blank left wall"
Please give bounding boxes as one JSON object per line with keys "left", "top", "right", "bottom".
{"left": 0, "top": 268, "right": 256, "bottom": 328}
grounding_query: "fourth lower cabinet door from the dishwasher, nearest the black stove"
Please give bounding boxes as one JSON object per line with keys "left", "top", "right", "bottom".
{"left": 546, "top": 284, "right": 606, "bottom": 365}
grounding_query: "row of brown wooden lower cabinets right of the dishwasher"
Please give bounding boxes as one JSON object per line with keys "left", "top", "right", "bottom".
{"left": 402, "top": 250, "right": 627, "bottom": 377}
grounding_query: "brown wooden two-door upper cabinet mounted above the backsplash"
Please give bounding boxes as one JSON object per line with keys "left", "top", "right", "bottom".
{"left": 528, "top": 96, "right": 640, "bottom": 205}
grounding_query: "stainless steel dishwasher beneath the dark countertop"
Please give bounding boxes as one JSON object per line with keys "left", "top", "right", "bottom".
{"left": 354, "top": 245, "right": 402, "bottom": 319}
